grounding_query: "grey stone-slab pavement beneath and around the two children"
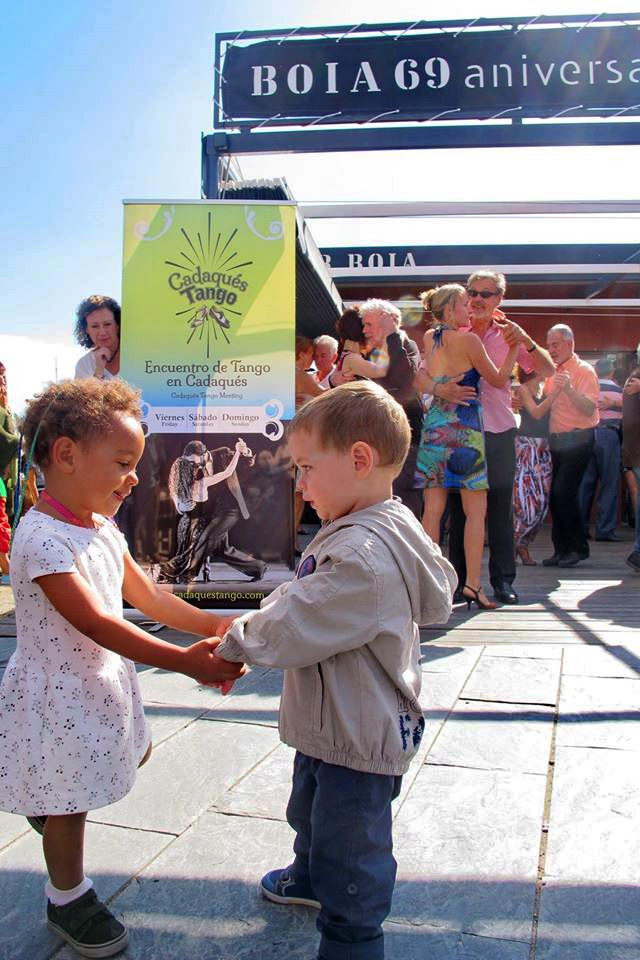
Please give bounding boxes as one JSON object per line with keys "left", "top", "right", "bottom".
{"left": 0, "top": 532, "right": 640, "bottom": 960}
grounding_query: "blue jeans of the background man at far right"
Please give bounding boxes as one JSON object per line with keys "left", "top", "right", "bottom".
{"left": 580, "top": 426, "right": 621, "bottom": 537}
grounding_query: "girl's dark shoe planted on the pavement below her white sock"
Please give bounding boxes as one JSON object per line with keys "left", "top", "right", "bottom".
{"left": 47, "top": 887, "right": 129, "bottom": 957}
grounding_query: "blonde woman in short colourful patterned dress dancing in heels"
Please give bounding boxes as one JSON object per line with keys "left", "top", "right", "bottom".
{"left": 417, "top": 283, "right": 517, "bottom": 610}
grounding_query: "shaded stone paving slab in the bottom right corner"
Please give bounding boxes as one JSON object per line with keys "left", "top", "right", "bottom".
{"left": 536, "top": 880, "right": 640, "bottom": 960}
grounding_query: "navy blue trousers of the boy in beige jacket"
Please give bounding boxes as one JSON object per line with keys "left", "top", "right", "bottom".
{"left": 287, "top": 752, "right": 402, "bottom": 960}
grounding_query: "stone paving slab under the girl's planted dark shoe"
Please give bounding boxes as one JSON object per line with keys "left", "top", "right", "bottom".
{"left": 0, "top": 818, "right": 170, "bottom": 960}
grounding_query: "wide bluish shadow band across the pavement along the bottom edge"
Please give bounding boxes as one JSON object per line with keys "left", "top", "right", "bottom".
{"left": 0, "top": 872, "right": 640, "bottom": 960}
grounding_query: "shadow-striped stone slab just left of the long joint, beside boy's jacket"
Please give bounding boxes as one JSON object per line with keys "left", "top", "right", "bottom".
{"left": 429, "top": 700, "right": 554, "bottom": 775}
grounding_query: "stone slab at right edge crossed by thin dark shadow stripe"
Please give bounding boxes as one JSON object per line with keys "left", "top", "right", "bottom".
{"left": 557, "top": 677, "right": 640, "bottom": 760}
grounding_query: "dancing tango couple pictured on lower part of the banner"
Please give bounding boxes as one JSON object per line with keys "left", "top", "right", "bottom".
{"left": 155, "top": 439, "right": 267, "bottom": 583}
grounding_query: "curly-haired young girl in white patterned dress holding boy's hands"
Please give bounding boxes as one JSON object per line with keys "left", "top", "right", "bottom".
{"left": 0, "top": 378, "right": 239, "bottom": 957}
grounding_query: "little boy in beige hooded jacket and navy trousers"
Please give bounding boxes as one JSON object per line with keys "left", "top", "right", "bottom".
{"left": 216, "top": 381, "right": 456, "bottom": 960}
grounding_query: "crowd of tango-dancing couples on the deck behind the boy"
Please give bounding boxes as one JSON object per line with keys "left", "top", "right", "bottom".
{"left": 298, "top": 270, "right": 640, "bottom": 596}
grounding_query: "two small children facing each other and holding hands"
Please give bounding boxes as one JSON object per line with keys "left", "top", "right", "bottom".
{"left": 0, "top": 379, "right": 456, "bottom": 960}
